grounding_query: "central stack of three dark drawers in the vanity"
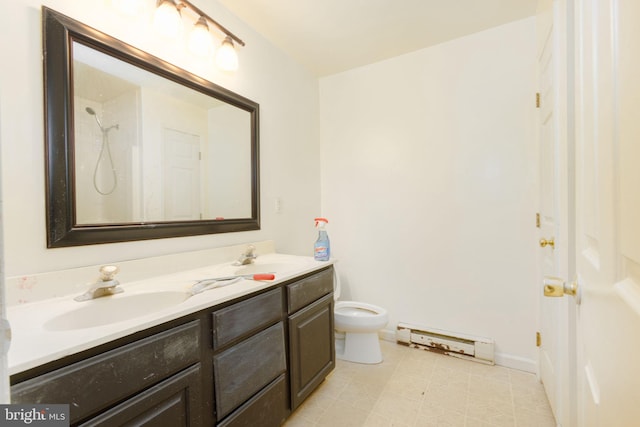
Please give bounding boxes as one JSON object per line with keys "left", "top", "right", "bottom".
{"left": 213, "top": 288, "right": 289, "bottom": 427}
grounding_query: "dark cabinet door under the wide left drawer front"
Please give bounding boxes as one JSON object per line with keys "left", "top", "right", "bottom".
{"left": 79, "top": 363, "right": 204, "bottom": 427}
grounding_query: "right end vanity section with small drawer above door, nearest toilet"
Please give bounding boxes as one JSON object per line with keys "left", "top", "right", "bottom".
{"left": 286, "top": 268, "right": 336, "bottom": 411}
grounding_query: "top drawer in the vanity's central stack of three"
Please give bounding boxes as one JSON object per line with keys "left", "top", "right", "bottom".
{"left": 212, "top": 288, "right": 283, "bottom": 350}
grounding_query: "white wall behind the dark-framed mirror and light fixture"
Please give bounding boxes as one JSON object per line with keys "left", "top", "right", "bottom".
{"left": 0, "top": 0, "right": 320, "bottom": 276}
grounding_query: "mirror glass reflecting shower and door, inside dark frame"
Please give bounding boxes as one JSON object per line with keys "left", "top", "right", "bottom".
{"left": 72, "top": 42, "right": 252, "bottom": 224}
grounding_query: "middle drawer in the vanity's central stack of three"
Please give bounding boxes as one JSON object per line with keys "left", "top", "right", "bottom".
{"left": 213, "top": 322, "right": 287, "bottom": 421}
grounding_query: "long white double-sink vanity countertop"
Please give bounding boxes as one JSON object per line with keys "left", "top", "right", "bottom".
{"left": 7, "top": 253, "right": 333, "bottom": 375}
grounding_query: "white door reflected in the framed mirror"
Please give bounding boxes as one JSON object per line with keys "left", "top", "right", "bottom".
{"left": 163, "top": 129, "right": 201, "bottom": 221}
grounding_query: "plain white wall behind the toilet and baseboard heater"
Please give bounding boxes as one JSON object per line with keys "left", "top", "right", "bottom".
{"left": 320, "top": 18, "right": 538, "bottom": 371}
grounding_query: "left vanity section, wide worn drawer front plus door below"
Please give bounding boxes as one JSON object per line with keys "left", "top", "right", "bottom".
{"left": 11, "top": 320, "right": 205, "bottom": 427}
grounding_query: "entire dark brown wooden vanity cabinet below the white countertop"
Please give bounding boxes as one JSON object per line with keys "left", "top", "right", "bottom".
{"left": 11, "top": 268, "right": 335, "bottom": 427}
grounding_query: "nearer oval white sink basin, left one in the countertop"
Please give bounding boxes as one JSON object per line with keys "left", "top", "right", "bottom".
{"left": 44, "top": 291, "right": 190, "bottom": 331}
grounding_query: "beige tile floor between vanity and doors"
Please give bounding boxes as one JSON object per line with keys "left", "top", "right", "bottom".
{"left": 284, "top": 341, "right": 555, "bottom": 427}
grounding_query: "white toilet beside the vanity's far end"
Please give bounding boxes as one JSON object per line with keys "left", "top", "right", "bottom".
{"left": 333, "top": 266, "right": 389, "bottom": 363}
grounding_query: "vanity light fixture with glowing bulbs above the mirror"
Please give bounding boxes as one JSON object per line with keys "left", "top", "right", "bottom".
{"left": 153, "top": 0, "right": 244, "bottom": 71}
